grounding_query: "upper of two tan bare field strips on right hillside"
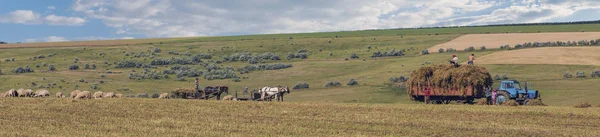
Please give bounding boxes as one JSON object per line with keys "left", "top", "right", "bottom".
{"left": 428, "top": 32, "right": 600, "bottom": 53}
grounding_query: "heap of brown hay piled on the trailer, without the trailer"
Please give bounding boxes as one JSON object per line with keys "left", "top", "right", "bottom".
{"left": 406, "top": 65, "right": 493, "bottom": 94}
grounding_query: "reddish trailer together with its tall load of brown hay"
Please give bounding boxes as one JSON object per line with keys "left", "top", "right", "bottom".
{"left": 406, "top": 65, "right": 493, "bottom": 103}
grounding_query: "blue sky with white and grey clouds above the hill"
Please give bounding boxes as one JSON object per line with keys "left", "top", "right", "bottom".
{"left": 0, "top": 0, "right": 600, "bottom": 43}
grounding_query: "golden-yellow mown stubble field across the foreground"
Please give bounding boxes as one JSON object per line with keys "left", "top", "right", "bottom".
{"left": 0, "top": 98, "right": 600, "bottom": 136}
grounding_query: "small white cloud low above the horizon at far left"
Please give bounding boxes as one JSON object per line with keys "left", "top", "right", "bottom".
{"left": 0, "top": 10, "right": 86, "bottom": 26}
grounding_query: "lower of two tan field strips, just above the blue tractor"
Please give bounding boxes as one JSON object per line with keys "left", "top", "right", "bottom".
{"left": 475, "top": 47, "right": 600, "bottom": 66}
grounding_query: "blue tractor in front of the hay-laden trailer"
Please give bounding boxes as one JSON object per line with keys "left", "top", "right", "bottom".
{"left": 496, "top": 80, "right": 540, "bottom": 105}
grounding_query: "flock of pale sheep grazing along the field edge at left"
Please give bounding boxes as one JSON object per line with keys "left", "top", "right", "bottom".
{"left": 0, "top": 89, "right": 169, "bottom": 99}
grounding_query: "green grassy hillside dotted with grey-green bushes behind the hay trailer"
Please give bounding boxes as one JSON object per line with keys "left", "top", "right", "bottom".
{"left": 0, "top": 24, "right": 600, "bottom": 105}
